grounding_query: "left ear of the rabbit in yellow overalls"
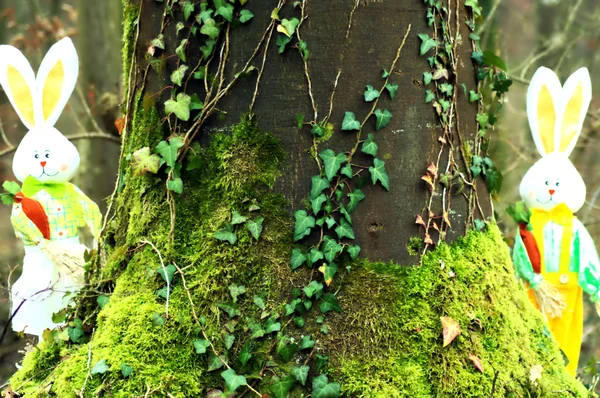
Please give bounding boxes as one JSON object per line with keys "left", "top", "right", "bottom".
{"left": 527, "top": 66, "right": 562, "bottom": 156}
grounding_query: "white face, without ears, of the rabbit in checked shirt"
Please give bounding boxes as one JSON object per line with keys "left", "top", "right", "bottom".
{"left": 13, "top": 127, "right": 80, "bottom": 182}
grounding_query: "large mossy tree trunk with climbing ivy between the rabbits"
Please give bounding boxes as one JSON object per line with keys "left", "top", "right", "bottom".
{"left": 4, "top": 0, "right": 585, "bottom": 397}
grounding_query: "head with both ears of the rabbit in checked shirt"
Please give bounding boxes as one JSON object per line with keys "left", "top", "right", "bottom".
{"left": 0, "top": 38, "right": 80, "bottom": 182}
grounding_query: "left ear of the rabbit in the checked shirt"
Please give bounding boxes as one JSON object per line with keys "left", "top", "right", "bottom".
{"left": 0, "top": 45, "right": 39, "bottom": 130}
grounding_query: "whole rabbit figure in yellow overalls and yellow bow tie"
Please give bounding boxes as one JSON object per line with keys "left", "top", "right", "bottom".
{"left": 513, "top": 67, "right": 600, "bottom": 375}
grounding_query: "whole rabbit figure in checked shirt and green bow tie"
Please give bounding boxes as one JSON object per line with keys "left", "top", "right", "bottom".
{"left": 0, "top": 38, "right": 102, "bottom": 337}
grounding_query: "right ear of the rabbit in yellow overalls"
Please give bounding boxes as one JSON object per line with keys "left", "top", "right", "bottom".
{"left": 555, "top": 68, "right": 592, "bottom": 156}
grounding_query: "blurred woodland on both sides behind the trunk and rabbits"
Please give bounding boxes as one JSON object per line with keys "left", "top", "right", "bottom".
{"left": 0, "top": 0, "right": 600, "bottom": 390}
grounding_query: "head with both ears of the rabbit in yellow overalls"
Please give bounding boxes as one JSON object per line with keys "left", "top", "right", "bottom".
{"left": 519, "top": 67, "right": 592, "bottom": 213}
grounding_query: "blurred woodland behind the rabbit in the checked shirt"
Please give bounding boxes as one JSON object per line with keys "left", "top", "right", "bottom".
{"left": 0, "top": 0, "right": 122, "bottom": 385}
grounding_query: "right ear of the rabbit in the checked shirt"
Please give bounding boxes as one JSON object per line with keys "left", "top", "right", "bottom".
{"left": 36, "top": 37, "right": 79, "bottom": 126}
